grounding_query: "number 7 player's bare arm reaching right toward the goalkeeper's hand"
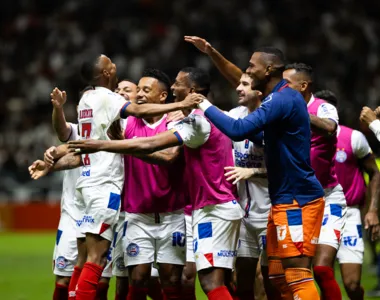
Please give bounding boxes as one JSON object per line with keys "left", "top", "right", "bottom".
{"left": 120, "top": 94, "right": 204, "bottom": 118}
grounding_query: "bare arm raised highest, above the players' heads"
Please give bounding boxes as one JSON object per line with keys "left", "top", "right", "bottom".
{"left": 185, "top": 36, "right": 243, "bottom": 88}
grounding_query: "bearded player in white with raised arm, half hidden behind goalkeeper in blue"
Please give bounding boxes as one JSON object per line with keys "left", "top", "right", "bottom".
{"left": 185, "top": 36, "right": 276, "bottom": 299}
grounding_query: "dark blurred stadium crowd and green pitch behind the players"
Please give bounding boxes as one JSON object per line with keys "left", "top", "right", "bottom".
{"left": 0, "top": 0, "right": 380, "bottom": 300}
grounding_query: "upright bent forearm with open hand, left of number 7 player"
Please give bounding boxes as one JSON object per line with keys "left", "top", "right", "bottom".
{"left": 50, "top": 88, "right": 72, "bottom": 142}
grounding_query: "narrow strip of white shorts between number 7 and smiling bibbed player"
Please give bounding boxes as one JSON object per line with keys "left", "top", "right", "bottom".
{"left": 112, "top": 212, "right": 128, "bottom": 277}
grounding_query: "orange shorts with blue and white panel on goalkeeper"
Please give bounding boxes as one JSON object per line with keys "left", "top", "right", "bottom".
{"left": 267, "top": 198, "right": 325, "bottom": 258}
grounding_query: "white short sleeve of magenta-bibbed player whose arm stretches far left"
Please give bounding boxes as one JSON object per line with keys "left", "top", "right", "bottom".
{"left": 172, "top": 114, "right": 211, "bottom": 148}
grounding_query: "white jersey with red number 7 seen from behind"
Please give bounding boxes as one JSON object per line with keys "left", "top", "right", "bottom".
{"left": 77, "top": 87, "right": 125, "bottom": 188}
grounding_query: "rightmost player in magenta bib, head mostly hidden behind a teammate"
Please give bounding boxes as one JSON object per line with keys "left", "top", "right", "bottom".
{"left": 315, "top": 91, "right": 380, "bottom": 300}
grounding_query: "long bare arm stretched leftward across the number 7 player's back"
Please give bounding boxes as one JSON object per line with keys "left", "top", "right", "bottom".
{"left": 69, "top": 131, "right": 182, "bottom": 155}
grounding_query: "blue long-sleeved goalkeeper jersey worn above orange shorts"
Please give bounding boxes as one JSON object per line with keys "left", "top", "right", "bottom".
{"left": 205, "top": 80, "right": 324, "bottom": 206}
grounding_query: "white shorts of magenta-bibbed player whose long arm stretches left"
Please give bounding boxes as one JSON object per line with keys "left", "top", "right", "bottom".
{"left": 193, "top": 213, "right": 241, "bottom": 271}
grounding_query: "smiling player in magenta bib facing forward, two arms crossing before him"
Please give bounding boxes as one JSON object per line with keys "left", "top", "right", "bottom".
{"left": 117, "top": 69, "right": 186, "bottom": 299}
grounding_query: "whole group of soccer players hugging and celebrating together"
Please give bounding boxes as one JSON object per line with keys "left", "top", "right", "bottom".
{"left": 29, "top": 36, "right": 380, "bottom": 300}
